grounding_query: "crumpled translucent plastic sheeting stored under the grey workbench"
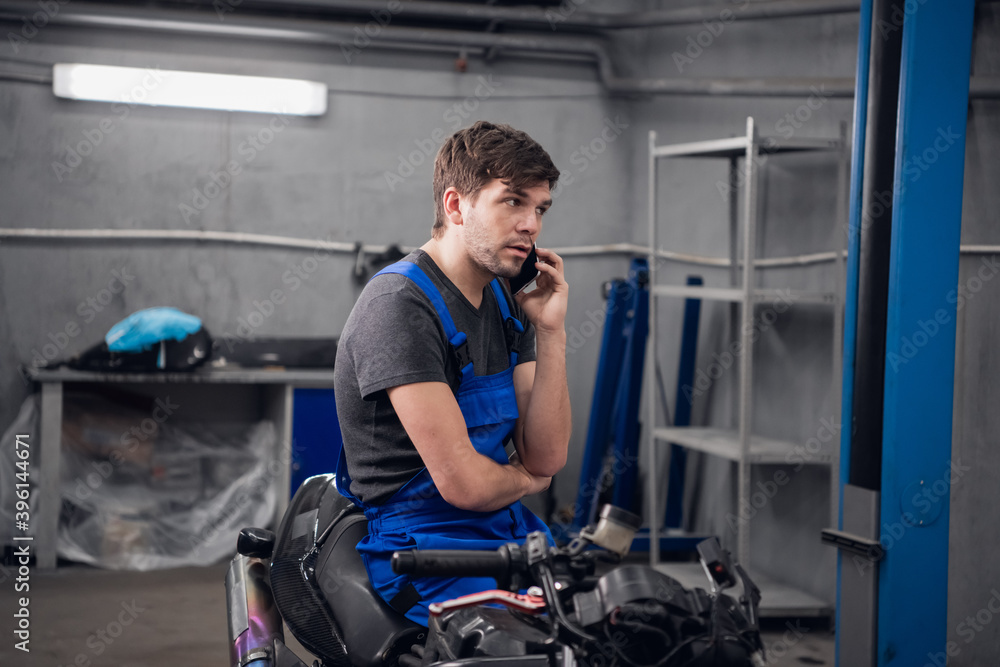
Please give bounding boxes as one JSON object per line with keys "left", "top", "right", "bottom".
{"left": 0, "top": 395, "right": 278, "bottom": 570}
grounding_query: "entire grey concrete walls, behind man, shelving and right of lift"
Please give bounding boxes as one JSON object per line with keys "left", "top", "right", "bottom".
{"left": 0, "top": 3, "right": 1000, "bottom": 665}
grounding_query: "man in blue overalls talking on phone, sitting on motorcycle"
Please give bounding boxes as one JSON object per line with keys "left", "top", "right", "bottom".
{"left": 335, "top": 121, "right": 570, "bottom": 625}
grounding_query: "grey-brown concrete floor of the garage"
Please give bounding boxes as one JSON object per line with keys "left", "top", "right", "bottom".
{"left": 0, "top": 564, "right": 834, "bottom": 667}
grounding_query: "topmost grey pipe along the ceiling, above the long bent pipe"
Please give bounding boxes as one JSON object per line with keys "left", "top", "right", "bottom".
{"left": 217, "top": 0, "right": 860, "bottom": 31}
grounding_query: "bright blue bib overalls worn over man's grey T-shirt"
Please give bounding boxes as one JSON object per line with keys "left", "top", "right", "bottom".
{"left": 337, "top": 262, "right": 552, "bottom": 625}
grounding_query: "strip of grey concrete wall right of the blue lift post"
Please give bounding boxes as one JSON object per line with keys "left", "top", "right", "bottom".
{"left": 944, "top": 3, "right": 1000, "bottom": 667}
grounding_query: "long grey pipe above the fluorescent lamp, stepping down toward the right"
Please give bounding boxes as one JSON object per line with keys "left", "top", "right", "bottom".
{"left": 0, "top": 2, "right": 854, "bottom": 97}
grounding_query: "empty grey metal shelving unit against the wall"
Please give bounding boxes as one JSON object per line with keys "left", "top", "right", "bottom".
{"left": 645, "top": 117, "right": 848, "bottom": 616}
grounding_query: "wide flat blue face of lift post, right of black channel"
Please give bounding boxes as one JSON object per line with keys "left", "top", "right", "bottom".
{"left": 878, "top": 0, "right": 975, "bottom": 666}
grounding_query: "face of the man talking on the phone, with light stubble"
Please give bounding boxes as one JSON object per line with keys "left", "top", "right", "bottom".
{"left": 462, "top": 179, "right": 552, "bottom": 278}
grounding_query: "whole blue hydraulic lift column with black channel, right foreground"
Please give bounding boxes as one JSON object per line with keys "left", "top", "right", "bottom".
{"left": 824, "top": 0, "right": 974, "bottom": 667}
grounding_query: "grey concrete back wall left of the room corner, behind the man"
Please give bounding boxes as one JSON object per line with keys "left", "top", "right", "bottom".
{"left": 0, "top": 18, "right": 631, "bottom": 516}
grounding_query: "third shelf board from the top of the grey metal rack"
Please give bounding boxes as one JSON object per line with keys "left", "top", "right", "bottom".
{"left": 653, "top": 426, "right": 834, "bottom": 465}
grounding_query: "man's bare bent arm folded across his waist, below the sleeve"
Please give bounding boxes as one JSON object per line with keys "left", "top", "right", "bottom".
{"left": 387, "top": 382, "right": 550, "bottom": 512}
